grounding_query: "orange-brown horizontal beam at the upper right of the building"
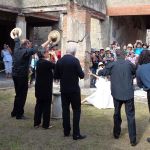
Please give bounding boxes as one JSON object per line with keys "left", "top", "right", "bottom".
{"left": 107, "top": 5, "right": 150, "bottom": 16}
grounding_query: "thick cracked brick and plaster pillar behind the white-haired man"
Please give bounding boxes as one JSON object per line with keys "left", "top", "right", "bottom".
{"left": 62, "top": 5, "right": 91, "bottom": 87}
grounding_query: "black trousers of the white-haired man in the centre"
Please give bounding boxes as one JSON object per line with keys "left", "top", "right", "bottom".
{"left": 61, "top": 92, "right": 81, "bottom": 136}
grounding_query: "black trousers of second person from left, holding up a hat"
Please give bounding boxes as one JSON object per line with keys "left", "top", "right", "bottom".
{"left": 34, "top": 97, "right": 52, "bottom": 128}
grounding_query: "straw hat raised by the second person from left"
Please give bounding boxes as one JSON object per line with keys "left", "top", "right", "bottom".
{"left": 48, "top": 30, "right": 60, "bottom": 45}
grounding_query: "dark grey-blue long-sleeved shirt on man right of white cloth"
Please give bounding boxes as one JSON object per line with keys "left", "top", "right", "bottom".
{"left": 98, "top": 59, "right": 136, "bottom": 100}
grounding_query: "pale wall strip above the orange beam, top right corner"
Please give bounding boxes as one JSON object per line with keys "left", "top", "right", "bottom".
{"left": 107, "top": 0, "right": 150, "bottom": 7}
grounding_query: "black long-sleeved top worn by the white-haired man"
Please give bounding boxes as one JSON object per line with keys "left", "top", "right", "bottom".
{"left": 54, "top": 54, "right": 84, "bottom": 93}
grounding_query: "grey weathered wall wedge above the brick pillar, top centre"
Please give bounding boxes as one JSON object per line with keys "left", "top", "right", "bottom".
{"left": 74, "top": 0, "right": 106, "bottom": 14}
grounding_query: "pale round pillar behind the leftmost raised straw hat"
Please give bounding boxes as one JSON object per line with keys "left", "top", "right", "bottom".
{"left": 16, "top": 15, "right": 26, "bottom": 39}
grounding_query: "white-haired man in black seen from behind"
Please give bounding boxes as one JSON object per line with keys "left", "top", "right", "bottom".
{"left": 54, "top": 43, "right": 86, "bottom": 140}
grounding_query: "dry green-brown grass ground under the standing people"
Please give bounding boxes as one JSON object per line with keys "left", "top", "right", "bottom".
{"left": 0, "top": 88, "right": 150, "bottom": 150}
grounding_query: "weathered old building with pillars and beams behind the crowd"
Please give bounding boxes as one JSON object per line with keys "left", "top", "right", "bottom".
{"left": 0, "top": 0, "right": 150, "bottom": 86}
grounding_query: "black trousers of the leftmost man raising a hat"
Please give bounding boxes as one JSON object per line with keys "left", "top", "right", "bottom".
{"left": 11, "top": 76, "right": 28, "bottom": 118}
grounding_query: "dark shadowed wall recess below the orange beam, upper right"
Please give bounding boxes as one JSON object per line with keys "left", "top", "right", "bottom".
{"left": 110, "top": 16, "right": 146, "bottom": 46}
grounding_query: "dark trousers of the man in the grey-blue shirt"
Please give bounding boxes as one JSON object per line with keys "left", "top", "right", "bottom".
{"left": 113, "top": 98, "right": 136, "bottom": 142}
